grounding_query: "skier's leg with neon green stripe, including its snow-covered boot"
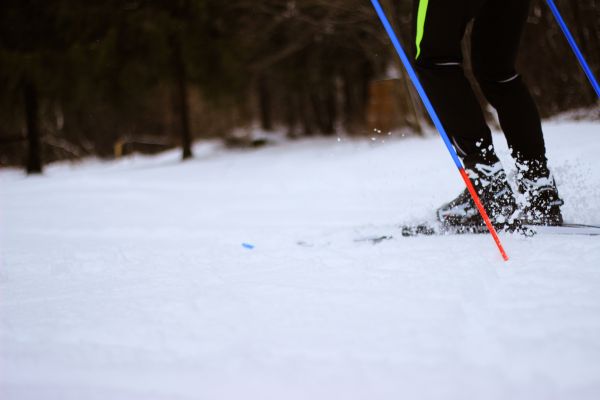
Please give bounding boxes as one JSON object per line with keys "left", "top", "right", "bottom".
{"left": 414, "top": 0, "right": 516, "bottom": 227}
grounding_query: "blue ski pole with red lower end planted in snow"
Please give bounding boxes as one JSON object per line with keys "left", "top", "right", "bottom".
{"left": 371, "top": 0, "right": 508, "bottom": 261}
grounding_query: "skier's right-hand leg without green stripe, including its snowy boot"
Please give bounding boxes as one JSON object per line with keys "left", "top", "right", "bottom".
{"left": 472, "top": 0, "right": 563, "bottom": 225}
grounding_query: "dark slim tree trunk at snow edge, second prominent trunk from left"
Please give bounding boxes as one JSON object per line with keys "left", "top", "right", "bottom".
{"left": 170, "top": 34, "right": 194, "bottom": 160}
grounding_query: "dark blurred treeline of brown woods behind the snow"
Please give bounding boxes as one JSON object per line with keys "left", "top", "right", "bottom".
{"left": 0, "top": 0, "right": 600, "bottom": 172}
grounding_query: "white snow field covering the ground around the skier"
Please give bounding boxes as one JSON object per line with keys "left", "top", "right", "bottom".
{"left": 0, "top": 121, "right": 600, "bottom": 400}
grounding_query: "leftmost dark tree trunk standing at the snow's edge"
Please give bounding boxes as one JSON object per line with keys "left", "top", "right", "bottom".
{"left": 23, "top": 79, "right": 42, "bottom": 174}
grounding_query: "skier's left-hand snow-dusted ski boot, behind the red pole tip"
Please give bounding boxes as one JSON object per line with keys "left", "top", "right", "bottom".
{"left": 437, "top": 161, "right": 519, "bottom": 232}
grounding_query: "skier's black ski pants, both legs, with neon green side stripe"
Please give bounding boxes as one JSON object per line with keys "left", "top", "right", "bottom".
{"left": 414, "top": 0, "right": 546, "bottom": 175}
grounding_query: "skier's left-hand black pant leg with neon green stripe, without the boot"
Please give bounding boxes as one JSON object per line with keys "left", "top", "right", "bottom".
{"left": 413, "top": 0, "right": 498, "bottom": 166}
